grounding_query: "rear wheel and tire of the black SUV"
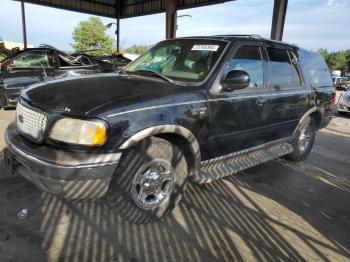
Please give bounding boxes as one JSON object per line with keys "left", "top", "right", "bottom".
{"left": 286, "top": 117, "right": 316, "bottom": 162}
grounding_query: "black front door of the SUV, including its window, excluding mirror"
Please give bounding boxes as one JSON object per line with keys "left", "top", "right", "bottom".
{"left": 203, "top": 42, "right": 271, "bottom": 159}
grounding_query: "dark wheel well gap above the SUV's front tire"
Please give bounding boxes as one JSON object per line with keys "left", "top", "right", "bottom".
{"left": 153, "top": 133, "right": 195, "bottom": 170}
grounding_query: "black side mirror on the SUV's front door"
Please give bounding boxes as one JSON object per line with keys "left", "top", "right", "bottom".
{"left": 222, "top": 70, "right": 250, "bottom": 92}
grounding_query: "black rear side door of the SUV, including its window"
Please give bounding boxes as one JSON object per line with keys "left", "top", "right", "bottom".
{"left": 266, "top": 46, "right": 308, "bottom": 140}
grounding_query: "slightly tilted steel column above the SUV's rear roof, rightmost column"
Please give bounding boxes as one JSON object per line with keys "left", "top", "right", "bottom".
{"left": 271, "top": 0, "right": 288, "bottom": 41}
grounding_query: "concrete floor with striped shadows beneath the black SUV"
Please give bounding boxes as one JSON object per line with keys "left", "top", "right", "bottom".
{"left": 0, "top": 111, "right": 350, "bottom": 261}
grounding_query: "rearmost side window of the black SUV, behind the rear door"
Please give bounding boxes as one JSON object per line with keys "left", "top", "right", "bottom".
{"left": 299, "top": 50, "right": 333, "bottom": 88}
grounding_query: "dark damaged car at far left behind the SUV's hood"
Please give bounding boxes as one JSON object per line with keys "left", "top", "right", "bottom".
{"left": 0, "top": 45, "right": 102, "bottom": 108}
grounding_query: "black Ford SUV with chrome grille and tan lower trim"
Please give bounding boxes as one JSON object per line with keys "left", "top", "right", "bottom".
{"left": 5, "top": 35, "right": 334, "bottom": 223}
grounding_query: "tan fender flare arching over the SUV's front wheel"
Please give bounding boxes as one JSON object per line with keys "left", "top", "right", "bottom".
{"left": 119, "top": 125, "right": 201, "bottom": 174}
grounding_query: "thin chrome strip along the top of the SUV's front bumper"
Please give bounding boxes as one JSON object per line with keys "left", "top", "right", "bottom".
{"left": 5, "top": 133, "right": 122, "bottom": 169}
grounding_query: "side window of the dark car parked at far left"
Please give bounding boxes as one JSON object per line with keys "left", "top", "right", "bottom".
{"left": 11, "top": 51, "right": 49, "bottom": 68}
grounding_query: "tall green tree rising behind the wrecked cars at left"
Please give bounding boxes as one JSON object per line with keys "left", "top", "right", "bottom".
{"left": 71, "top": 17, "right": 114, "bottom": 55}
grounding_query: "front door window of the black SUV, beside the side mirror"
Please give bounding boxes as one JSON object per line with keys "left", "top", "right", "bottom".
{"left": 227, "top": 46, "right": 264, "bottom": 88}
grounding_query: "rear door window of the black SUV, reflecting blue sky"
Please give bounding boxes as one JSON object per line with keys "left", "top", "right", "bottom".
{"left": 267, "top": 48, "right": 300, "bottom": 90}
